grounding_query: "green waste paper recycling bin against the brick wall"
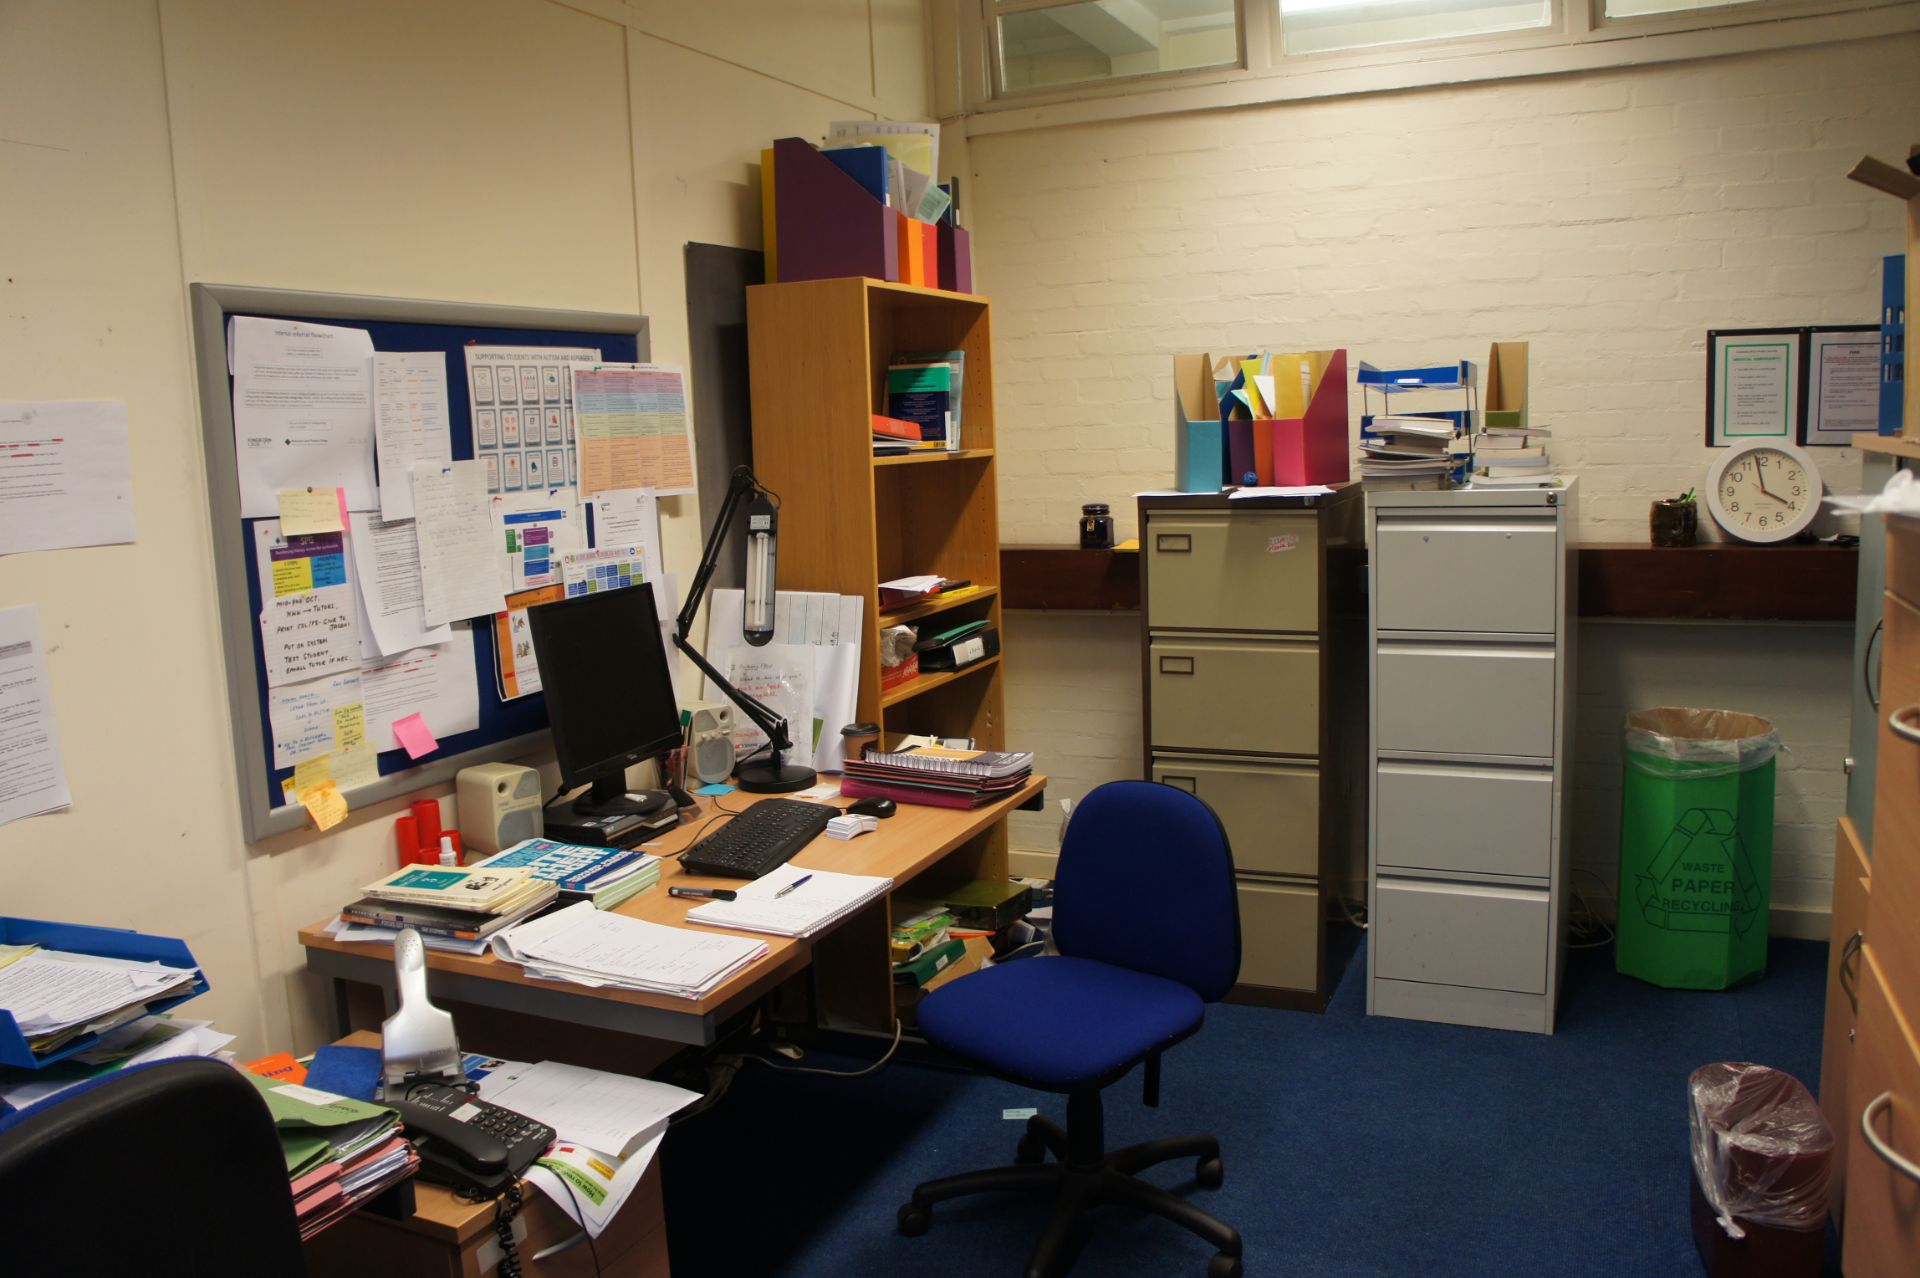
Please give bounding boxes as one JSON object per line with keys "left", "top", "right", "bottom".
{"left": 1615, "top": 706, "right": 1780, "bottom": 990}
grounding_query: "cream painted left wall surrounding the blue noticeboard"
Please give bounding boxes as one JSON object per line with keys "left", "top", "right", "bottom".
{"left": 0, "top": 0, "right": 927, "bottom": 1052}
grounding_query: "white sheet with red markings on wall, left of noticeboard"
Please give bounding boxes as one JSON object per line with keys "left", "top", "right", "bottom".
{"left": 0, "top": 399, "right": 132, "bottom": 555}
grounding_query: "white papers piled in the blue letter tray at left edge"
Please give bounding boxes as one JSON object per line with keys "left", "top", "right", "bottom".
{"left": 0, "top": 946, "right": 200, "bottom": 1055}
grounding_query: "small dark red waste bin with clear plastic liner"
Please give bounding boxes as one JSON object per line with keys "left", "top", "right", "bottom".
{"left": 1688, "top": 1061, "right": 1834, "bottom": 1278}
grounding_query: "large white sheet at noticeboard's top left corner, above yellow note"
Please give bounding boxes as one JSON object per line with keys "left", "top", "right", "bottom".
{"left": 227, "top": 315, "right": 378, "bottom": 520}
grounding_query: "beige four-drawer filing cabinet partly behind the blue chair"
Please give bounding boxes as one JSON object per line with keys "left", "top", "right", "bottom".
{"left": 1140, "top": 484, "right": 1367, "bottom": 1011}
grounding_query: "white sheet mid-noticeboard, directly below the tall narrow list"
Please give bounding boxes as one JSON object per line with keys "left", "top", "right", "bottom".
{"left": 413, "top": 461, "right": 507, "bottom": 626}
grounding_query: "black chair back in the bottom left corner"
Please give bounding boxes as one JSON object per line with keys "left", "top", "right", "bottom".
{"left": 0, "top": 1057, "right": 307, "bottom": 1278}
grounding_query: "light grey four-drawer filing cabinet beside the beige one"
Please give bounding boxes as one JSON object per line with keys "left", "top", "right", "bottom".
{"left": 1367, "top": 482, "right": 1576, "bottom": 1034}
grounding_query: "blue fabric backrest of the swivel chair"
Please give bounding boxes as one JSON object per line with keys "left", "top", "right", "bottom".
{"left": 1054, "top": 781, "right": 1240, "bottom": 1002}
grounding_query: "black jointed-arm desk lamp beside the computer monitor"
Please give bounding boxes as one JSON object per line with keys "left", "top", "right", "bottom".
{"left": 674, "top": 466, "right": 816, "bottom": 794}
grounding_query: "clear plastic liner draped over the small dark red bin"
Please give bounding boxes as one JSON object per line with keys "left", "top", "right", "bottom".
{"left": 1688, "top": 1061, "right": 1834, "bottom": 1235}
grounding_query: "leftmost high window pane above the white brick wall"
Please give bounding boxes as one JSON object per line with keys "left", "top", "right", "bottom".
{"left": 995, "top": 0, "right": 1240, "bottom": 92}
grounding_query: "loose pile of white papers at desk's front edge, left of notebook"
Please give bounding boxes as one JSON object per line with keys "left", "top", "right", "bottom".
{"left": 493, "top": 902, "right": 766, "bottom": 998}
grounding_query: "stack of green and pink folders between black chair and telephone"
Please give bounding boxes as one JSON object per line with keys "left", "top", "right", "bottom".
{"left": 244, "top": 1073, "right": 420, "bottom": 1240}
